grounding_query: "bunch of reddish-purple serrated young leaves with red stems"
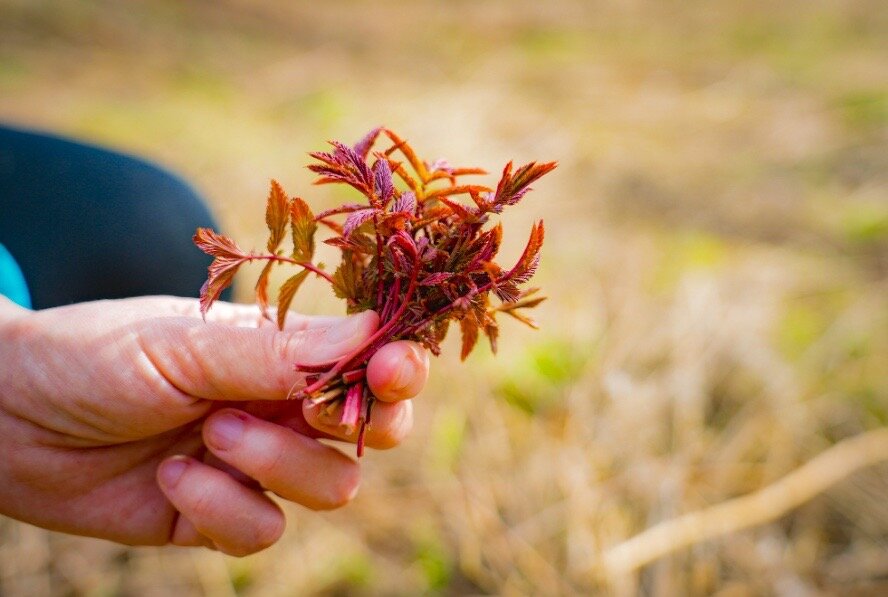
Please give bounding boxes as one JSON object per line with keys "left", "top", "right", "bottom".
{"left": 194, "top": 127, "right": 556, "bottom": 452}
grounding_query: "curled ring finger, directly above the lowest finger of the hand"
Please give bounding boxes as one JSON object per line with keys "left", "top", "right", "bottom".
{"left": 203, "top": 408, "right": 361, "bottom": 510}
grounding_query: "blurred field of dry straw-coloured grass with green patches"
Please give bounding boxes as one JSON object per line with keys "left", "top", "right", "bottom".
{"left": 0, "top": 0, "right": 888, "bottom": 596}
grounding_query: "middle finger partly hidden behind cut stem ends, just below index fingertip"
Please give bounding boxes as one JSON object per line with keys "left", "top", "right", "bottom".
{"left": 302, "top": 400, "right": 413, "bottom": 450}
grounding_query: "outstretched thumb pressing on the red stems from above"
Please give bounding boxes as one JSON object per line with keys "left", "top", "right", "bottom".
{"left": 137, "top": 311, "right": 379, "bottom": 400}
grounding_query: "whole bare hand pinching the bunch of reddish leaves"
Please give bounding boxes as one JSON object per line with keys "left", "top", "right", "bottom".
{"left": 0, "top": 297, "right": 428, "bottom": 556}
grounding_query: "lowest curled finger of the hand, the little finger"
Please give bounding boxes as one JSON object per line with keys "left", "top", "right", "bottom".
{"left": 157, "top": 456, "right": 285, "bottom": 556}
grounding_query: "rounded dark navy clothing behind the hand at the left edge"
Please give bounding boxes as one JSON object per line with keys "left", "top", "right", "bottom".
{"left": 0, "top": 127, "right": 229, "bottom": 309}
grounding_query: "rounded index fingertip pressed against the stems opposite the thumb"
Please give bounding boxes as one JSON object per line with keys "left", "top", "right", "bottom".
{"left": 367, "top": 340, "right": 429, "bottom": 402}
